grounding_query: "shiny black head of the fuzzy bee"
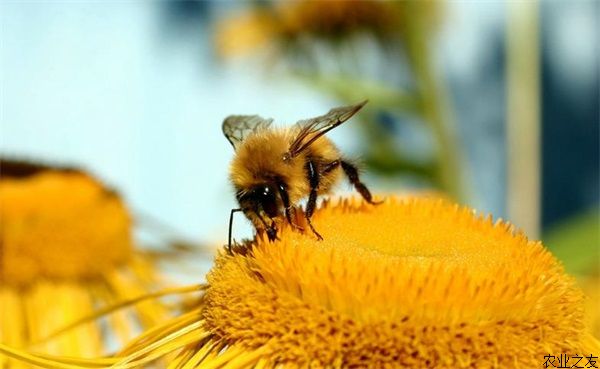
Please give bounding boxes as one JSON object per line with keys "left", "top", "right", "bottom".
{"left": 237, "top": 183, "right": 280, "bottom": 221}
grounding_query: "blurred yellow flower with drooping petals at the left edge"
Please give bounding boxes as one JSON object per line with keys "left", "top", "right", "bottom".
{"left": 0, "top": 160, "right": 183, "bottom": 368}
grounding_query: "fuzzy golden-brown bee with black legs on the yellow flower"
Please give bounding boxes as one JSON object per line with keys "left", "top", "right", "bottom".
{"left": 222, "top": 100, "right": 377, "bottom": 252}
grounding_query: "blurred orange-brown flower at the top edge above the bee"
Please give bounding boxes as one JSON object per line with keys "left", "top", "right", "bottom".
{"left": 216, "top": 0, "right": 440, "bottom": 57}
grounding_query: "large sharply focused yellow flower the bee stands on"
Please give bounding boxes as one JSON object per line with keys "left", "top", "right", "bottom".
{"left": 109, "top": 197, "right": 600, "bottom": 368}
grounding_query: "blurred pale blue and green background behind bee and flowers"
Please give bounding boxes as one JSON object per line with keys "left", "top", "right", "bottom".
{"left": 0, "top": 0, "right": 600, "bottom": 304}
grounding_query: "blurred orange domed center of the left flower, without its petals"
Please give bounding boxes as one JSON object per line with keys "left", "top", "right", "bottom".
{"left": 0, "top": 170, "right": 132, "bottom": 284}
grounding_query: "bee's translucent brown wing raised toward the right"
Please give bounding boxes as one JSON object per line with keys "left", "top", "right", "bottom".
{"left": 288, "top": 100, "right": 368, "bottom": 157}
